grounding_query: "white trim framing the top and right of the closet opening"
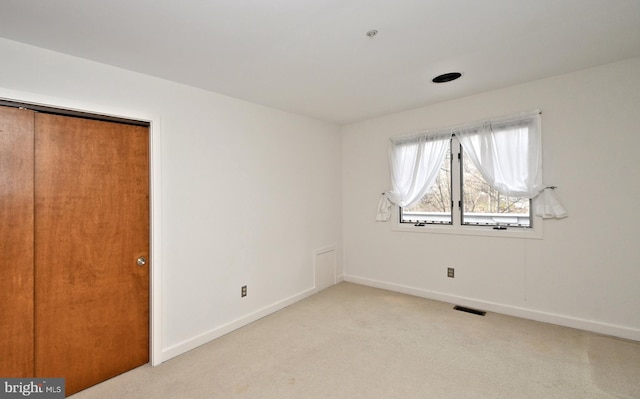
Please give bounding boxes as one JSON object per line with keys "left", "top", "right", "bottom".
{"left": 0, "top": 87, "right": 164, "bottom": 366}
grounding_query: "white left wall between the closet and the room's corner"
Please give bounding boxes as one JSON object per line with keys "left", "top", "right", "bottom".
{"left": 0, "top": 39, "right": 342, "bottom": 362}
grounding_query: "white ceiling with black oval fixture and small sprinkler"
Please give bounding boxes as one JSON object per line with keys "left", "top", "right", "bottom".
{"left": 0, "top": 0, "right": 640, "bottom": 124}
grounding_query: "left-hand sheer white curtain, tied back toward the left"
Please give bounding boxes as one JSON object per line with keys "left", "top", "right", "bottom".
{"left": 376, "top": 133, "right": 451, "bottom": 221}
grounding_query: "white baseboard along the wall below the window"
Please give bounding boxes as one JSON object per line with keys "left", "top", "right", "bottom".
{"left": 343, "top": 275, "right": 640, "bottom": 341}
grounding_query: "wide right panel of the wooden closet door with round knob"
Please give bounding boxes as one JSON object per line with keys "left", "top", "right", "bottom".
{"left": 35, "top": 114, "right": 149, "bottom": 394}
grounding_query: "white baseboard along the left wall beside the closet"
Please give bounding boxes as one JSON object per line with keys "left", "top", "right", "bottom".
{"left": 161, "top": 287, "right": 316, "bottom": 362}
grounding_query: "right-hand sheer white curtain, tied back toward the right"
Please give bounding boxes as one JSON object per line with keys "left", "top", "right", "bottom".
{"left": 453, "top": 112, "right": 567, "bottom": 218}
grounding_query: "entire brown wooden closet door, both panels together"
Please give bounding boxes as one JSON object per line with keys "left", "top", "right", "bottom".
{"left": 0, "top": 107, "right": 149, "bottom": 394}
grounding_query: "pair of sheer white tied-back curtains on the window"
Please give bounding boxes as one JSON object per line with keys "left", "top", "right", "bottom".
{"left": 376, "top": 111, "right": 567, "bottom": 221}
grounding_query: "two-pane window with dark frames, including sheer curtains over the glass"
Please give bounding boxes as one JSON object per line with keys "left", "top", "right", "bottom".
{"left": 389, "top": 112, "right": 541, "bottom": 230}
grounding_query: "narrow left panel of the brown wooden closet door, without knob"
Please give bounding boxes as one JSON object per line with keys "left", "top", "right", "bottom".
{"left": 0, "top": 107, "right": 34, "bottom": 378}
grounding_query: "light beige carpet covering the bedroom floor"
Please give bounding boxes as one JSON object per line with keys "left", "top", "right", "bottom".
{"left": 71, "top": 283, "right": 640, "bottom": 399}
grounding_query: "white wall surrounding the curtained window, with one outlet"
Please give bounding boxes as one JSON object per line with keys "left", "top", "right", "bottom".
{"left": 343, "top": 59, "right": 640, "bottom": 340}
